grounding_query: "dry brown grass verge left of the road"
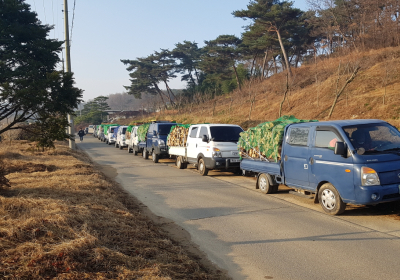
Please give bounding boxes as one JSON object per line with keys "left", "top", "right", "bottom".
{"left": 0, "top": 141, "right": 222, "bottom": 279}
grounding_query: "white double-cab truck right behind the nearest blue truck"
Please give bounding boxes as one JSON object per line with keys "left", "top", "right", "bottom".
{"left": 169, "top": 124, "right": 243, "bottom": 176}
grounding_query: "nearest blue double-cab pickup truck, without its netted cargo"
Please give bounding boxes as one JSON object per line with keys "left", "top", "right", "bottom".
{"left": 240, "top": 120, "right": 400, "bottom": 215}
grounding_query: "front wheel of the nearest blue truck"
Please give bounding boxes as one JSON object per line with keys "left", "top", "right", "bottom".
{"left": 318, "top": 183, "right": 346, "bottom": 215}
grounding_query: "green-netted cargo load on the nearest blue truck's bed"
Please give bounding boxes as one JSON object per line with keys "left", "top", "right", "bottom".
{"left": 238, "top": 116, "right": 317, "bottom": 161}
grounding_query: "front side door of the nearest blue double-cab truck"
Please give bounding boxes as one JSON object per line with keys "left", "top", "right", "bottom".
{"left": 310, "top": 126, "right": 355, "bottom": 200}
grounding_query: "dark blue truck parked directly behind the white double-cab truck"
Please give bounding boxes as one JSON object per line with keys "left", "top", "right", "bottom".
{"left": 138, "top": 121, "right": 180, "bottom": 163}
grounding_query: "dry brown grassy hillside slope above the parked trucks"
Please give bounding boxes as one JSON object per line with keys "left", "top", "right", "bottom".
{"left": 139, "top": 47, "right": 400, "bottom": 128}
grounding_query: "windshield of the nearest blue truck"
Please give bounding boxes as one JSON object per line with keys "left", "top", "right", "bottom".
{"left": 343, "top": 123, "right": 400, "bottom": 155}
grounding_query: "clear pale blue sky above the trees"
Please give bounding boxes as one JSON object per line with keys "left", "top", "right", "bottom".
{"left": 26, "top": 0, "right": 308, "bottom": 101}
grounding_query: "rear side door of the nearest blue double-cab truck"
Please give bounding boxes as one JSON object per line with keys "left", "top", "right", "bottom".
{"left": 283, "top": 126, "right": 310, "bottom": 189}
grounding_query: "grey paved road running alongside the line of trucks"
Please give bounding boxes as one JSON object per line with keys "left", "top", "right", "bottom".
{"left": 78, "top": 135, "right": 400, "bottom": 279}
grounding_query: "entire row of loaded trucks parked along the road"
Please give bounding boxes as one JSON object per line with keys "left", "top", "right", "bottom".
{"left": 88, "top": 117, "right": 400, "bottom": 215}
